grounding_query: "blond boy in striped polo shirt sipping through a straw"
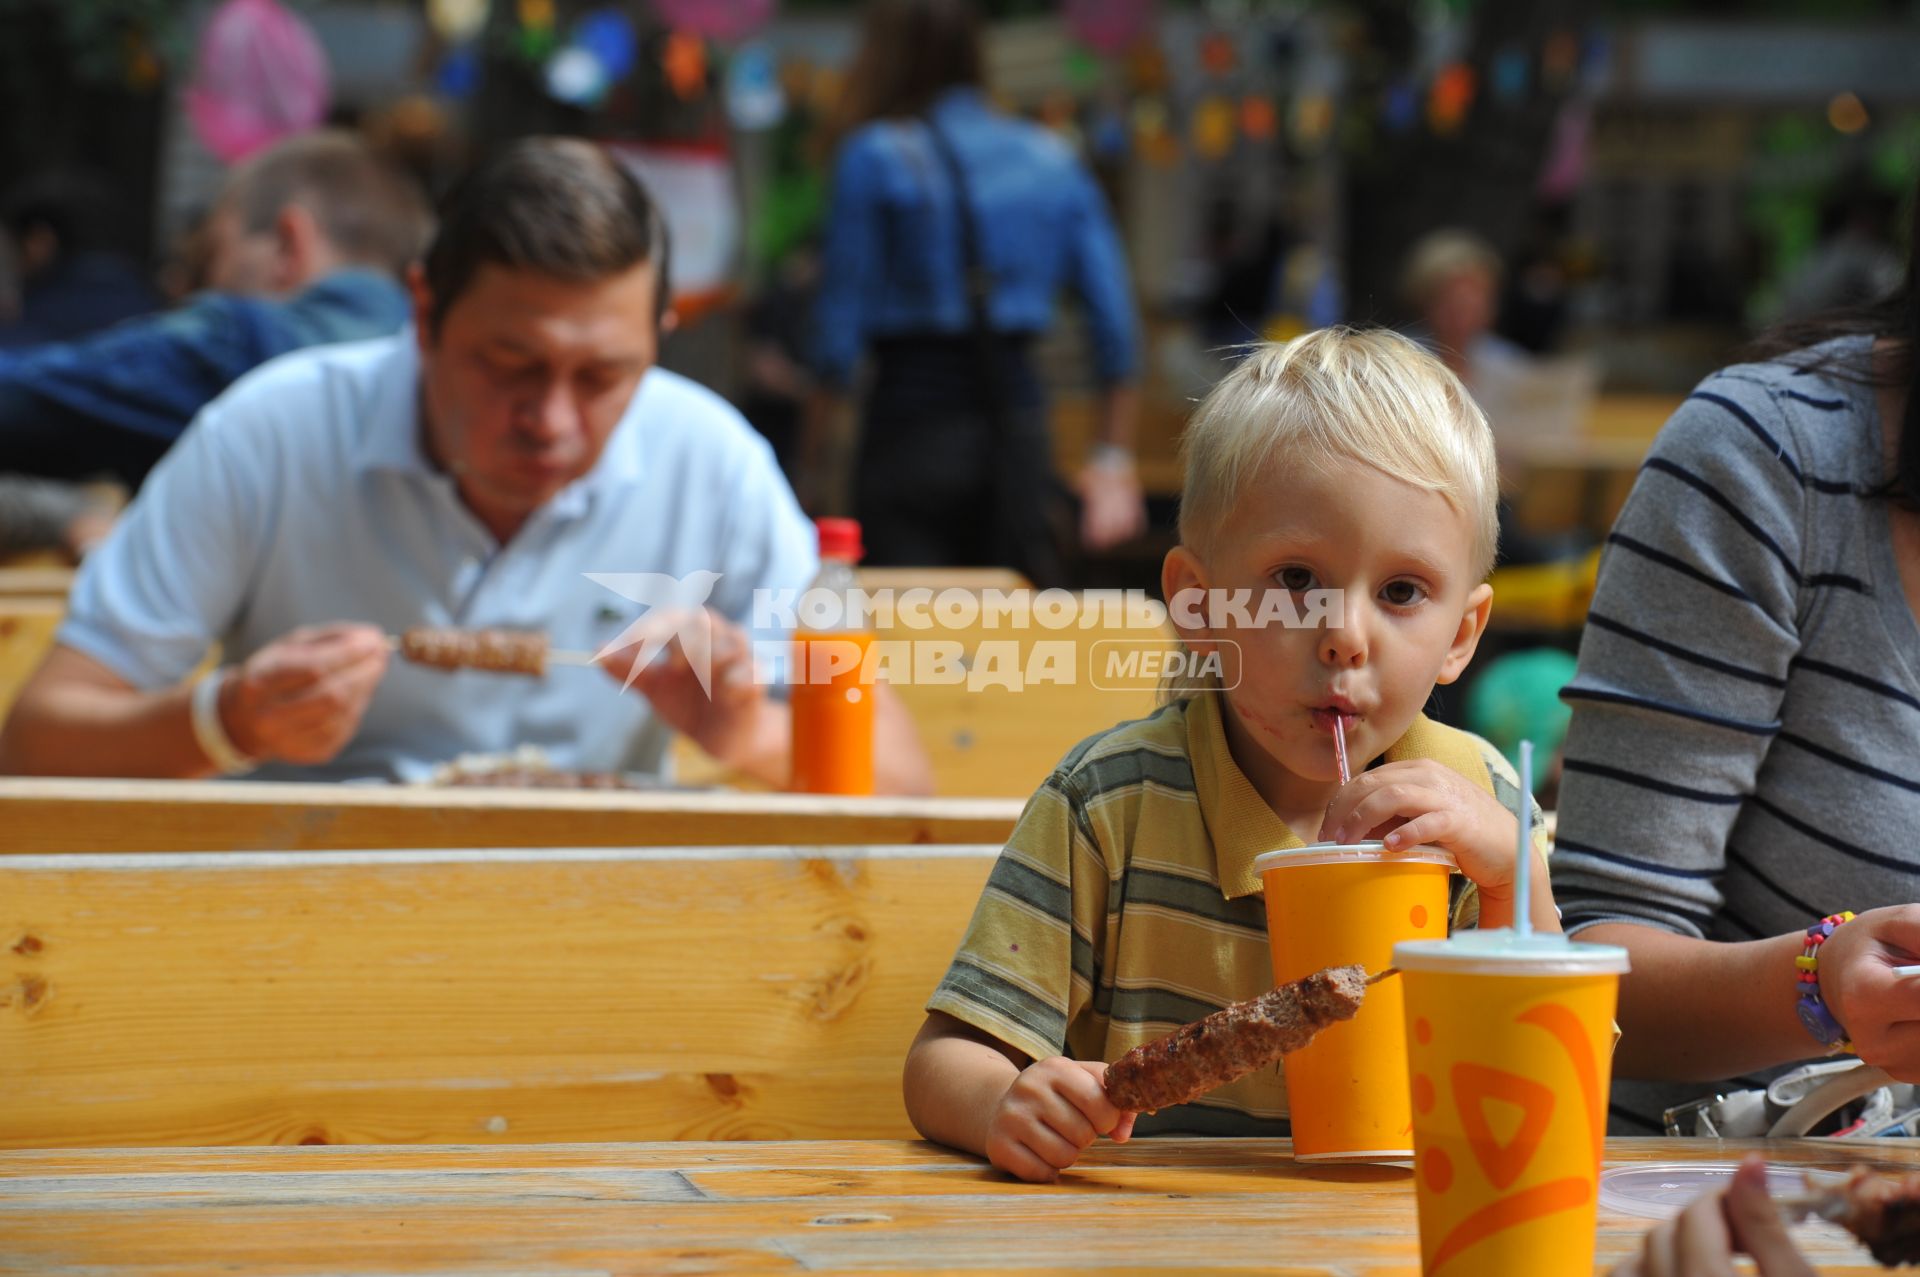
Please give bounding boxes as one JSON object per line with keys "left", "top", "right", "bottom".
{"left": 904, "top": 328, "right": 1559, "bottom": 1181}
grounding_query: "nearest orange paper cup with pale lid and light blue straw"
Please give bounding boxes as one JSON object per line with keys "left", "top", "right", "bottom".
{"left": 1394, "top": 929, "right": 1626, "bottom": 1277}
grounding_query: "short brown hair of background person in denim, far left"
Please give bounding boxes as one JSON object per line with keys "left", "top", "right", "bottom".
{"left": 221, "top": 129, "right": 432, "bottom": 277}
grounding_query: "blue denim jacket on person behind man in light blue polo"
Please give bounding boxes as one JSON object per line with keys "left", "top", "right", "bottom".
{"left": 0, "top": 269, "right": 409, "bottom": 443}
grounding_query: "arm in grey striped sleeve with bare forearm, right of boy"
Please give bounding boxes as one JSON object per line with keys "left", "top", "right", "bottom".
{"left": 1553, "top": 378, "right": 1818, "bottom": 1077}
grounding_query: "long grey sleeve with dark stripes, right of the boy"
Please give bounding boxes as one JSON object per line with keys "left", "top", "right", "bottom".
{"left": 1553, "top": 374, "right": 1822, "bottom": 937}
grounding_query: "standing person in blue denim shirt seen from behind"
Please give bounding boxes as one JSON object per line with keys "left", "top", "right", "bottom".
{"left": 808, "top": 0, "right": 1144, "bottom": 584}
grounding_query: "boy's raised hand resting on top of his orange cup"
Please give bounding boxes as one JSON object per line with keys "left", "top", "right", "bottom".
{"left": 1321, "top": 759, "right": 1521, "bottom": 899}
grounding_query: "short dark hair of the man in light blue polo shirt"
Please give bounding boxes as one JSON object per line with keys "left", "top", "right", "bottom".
{"left": 426, "top": 138, "right": 668, "bottom": 328}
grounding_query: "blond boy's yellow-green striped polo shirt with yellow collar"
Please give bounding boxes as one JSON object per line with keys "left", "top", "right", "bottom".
{"left": 927, "top": 693, "right": 1540, "bottom": 1135}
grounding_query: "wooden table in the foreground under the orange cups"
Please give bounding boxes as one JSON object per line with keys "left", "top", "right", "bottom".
{"left": 0, "top": 1139, "right": 1916, "bottom": 1277}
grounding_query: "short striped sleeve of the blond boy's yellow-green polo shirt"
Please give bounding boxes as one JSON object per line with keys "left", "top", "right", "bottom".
{"left": 927, "top": 774, "right": 1110, "bottom": 1060}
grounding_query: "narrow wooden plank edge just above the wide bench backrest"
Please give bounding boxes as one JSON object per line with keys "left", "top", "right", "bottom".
{"left": 0, "top": 778, "right": 1021, "bottom": 855}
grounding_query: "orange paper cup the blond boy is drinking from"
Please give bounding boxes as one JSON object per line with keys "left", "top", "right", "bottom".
{"left": 1254, "top": 843, "right": 1455, "bottom": 1162}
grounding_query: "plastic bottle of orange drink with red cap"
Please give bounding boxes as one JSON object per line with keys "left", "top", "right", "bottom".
{"left": 791, "top": 518, "right": 874, "bottom": 793}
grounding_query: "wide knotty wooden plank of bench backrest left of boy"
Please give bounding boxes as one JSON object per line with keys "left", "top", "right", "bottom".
{"left": 0, "top": 845, "right": 998, "bottom": 1148}
